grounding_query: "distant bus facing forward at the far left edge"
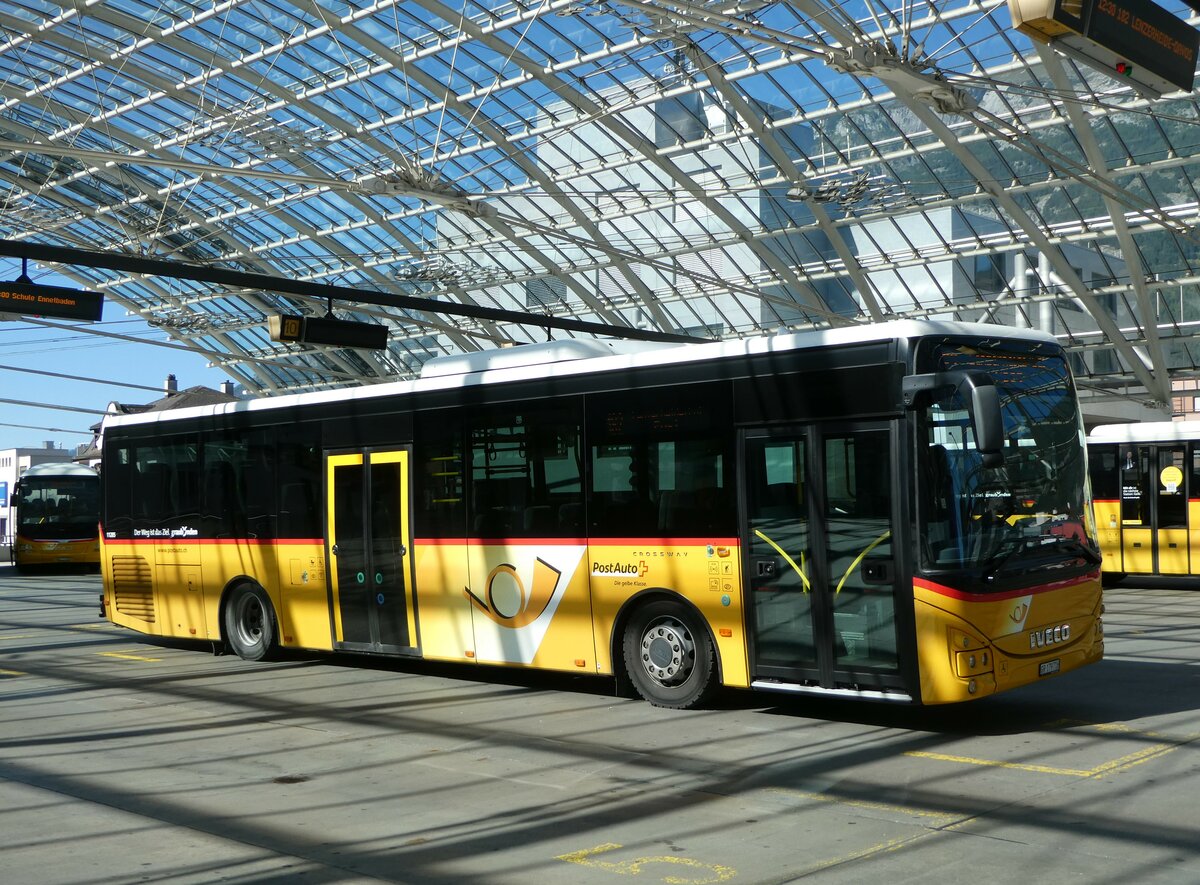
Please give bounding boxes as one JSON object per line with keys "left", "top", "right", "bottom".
{"left": 10, "top": 464, "right": 100, "bottom": 570}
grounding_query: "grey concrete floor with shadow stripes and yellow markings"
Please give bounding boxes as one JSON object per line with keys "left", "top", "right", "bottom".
{"left": 0, "top": 565, "right": 1200, "bottom": 885}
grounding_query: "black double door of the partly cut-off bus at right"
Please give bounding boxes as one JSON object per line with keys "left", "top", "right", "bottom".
{"left": 1118, "top": 443, "right": 1189, "bottom": 574}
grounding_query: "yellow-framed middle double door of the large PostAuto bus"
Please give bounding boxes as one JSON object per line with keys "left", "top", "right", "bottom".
{"left": 325, "top": 451, "right": 418, "bottom": 654}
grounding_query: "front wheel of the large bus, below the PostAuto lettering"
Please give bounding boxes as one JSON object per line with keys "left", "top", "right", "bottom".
{"left": 622, "top": 600, "right": 716, "bottom": 710}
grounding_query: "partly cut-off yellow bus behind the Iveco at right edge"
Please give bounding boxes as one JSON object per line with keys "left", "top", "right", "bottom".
{"left": 1087, "top": 421, "right": 1200, "bottom": 580}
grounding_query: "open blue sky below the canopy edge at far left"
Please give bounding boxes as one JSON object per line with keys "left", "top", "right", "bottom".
{"left": 0, "top": 258, "right": 238, "bottom": 450}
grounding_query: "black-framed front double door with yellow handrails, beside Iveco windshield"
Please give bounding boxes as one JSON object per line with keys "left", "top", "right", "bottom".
{"left": 743, "top": 425, "right": 905, "bottom": 693}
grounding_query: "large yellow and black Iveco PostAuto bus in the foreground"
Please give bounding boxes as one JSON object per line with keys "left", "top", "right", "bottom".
{"left": 102, "top": 321, "right": 1104, "bottom": 708}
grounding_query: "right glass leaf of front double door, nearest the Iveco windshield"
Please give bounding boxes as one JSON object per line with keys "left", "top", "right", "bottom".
{"left": 824, "top": 431, "right": 899, "bottom": 670}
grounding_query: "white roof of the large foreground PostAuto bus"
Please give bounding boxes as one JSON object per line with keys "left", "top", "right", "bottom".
{"left": 103, "top": 320, "right": 1058, "bottom": 429}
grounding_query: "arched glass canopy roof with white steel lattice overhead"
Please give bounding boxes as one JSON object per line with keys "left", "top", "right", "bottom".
{"left": 0, "top": 0, "right": 1200, "bottom": 412}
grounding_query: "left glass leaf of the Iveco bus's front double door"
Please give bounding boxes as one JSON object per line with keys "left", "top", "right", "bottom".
{"left": 746, "top": 439, "right": 817, "bottom": 668}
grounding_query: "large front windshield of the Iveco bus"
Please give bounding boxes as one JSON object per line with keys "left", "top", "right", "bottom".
{"left": 918, "top": 345, "right": 1099, "bottom": 590}
